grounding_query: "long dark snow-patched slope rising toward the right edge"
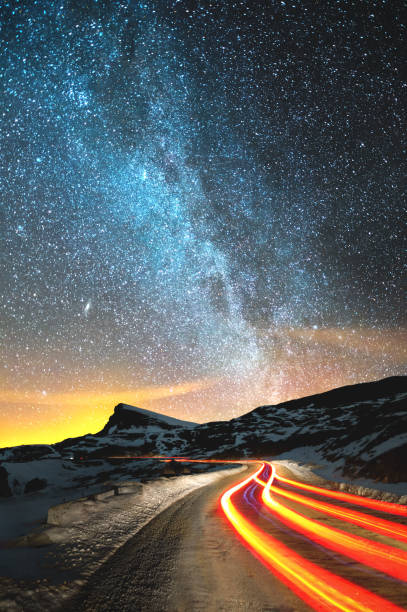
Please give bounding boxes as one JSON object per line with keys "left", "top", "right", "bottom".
{"left": 188, "top": 377, "right": 407, "bottom": 482}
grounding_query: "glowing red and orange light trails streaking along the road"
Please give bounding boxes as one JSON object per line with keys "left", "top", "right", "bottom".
{"left": 119, "top": 456, "right": 407, "bottom": 612}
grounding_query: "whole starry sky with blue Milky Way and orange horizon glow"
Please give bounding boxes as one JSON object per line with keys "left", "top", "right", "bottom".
{"left": 0, "top": 0, "right": 407, "bottom": 446}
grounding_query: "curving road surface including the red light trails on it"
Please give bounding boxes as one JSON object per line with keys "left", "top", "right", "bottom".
{"left": 64, "top": 463, "right": 407, "bottom": 612}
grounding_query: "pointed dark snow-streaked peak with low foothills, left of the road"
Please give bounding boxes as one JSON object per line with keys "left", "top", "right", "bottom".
{"left": 0, "top": 404, "right": 196, "bottom": 498}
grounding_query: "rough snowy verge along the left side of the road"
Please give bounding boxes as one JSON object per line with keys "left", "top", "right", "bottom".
{"left": 0, "top": 467, "right": 245, "bottom": 612}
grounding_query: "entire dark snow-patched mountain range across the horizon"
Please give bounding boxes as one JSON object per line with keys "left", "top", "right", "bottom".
{"left": 0, "top": 377, "right": 407, "bottom": 495}
